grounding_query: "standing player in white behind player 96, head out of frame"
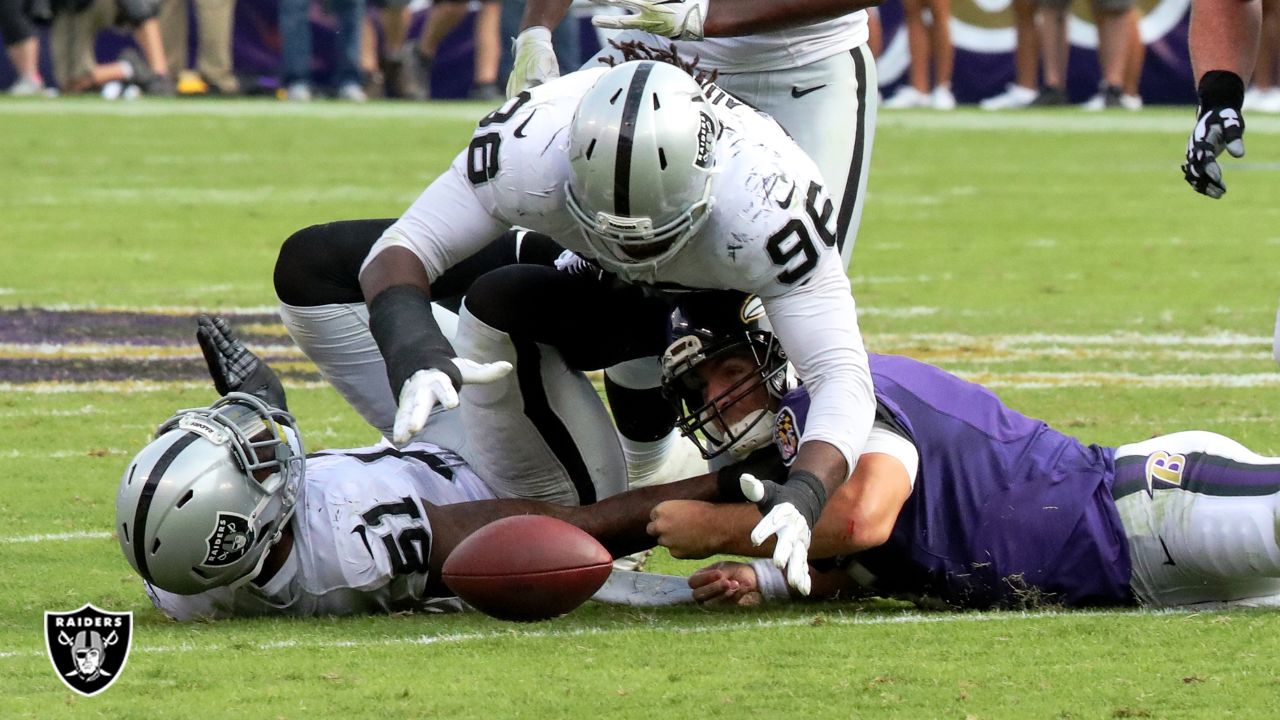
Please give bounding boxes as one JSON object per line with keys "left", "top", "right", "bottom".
{"left": 507, "top": 0, "right": 881, "bottom": 266}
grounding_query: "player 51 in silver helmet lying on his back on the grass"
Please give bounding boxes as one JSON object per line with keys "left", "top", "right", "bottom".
{"left": 116, "top": 318, "right": 717, "bottom": 620}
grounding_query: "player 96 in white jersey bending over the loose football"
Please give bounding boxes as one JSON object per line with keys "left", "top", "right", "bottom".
{"left": 360, "top": 61, "right": 874, "bottom": 589}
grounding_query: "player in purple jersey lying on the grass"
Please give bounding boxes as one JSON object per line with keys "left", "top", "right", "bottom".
{"left": 650, "top": 294, "right": 1280, "bottom": 607}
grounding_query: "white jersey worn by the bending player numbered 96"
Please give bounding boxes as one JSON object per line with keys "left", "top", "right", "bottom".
{"left": 361, "top": 68, "right": 876, "bottom": 469}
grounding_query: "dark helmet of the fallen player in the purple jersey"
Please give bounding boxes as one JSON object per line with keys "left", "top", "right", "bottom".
{"left": 662, "top": 291, "right": 800, "bottom": 460}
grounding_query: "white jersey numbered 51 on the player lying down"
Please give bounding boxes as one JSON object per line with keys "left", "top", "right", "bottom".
{"left": 147, "top": 443, "right": 494, "bottom": 620}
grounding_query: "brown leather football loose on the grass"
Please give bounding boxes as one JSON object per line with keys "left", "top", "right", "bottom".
{"left": 443, "top": 515, "right": 613, "bottom": 623}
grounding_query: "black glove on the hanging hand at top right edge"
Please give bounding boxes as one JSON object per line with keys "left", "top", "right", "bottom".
{"left": 1183, "top": 70, "right": 1244, "bottom": 200}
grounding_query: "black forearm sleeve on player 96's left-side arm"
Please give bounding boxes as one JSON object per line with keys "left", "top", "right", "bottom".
{"left": 369, "top": 284, "right": 462, "bottom": 398}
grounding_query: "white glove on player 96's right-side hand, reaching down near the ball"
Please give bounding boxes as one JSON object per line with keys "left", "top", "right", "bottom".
{"left": 739, "top": 470, "right": 827, "bottom": 594}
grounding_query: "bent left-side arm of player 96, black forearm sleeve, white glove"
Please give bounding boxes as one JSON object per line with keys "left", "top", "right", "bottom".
{"left": 360, "top": 160, "right": 511, "bottom": 446}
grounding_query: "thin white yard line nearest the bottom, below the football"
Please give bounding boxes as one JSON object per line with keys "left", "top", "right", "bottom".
{"left": 0, "top": 602, "right": 1172, "bottom": 659}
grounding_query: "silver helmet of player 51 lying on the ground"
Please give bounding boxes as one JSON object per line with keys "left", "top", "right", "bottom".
{"left": 115, "top": 392, "right": 306, "bottom": 594}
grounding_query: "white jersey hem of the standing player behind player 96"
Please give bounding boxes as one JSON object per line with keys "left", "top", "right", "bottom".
{"left": 605, "top": 10, "right": 870, "bottom": 73}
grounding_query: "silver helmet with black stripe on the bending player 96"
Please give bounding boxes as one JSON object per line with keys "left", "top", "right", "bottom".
{"left": 566, "top": 60, "right": 721, "bottom": 279}
